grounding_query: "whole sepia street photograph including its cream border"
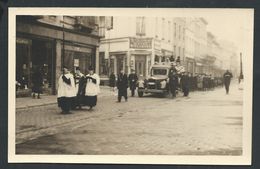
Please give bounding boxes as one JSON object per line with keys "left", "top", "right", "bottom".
{"left": 8, "top": 8, "right": 254, "bottom": 165}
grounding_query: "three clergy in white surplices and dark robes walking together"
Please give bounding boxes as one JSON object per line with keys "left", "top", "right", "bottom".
{"left": 57, "top": 66, "right": 100, "bottom": 114}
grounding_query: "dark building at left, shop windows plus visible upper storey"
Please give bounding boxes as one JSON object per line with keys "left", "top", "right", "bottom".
{"left": 16, "top": 16, "right": 100, "bottom": 94}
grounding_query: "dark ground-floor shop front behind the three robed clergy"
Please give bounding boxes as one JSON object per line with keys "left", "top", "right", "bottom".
{"left": 16, "top": 20, "right": 99, "bottom": 97}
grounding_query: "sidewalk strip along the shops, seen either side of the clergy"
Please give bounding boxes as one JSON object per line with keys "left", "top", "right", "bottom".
{"left": 16, "top": 86, "right": 114, "bottom": 110}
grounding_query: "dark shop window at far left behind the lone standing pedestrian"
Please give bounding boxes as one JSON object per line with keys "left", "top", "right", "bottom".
{"left": 16, "top": 37, "right": 55, "bottom": 96}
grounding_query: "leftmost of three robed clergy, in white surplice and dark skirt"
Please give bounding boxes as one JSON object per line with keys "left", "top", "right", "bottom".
{"left": 58, "top": 67, "right": 76, "bottom": 114}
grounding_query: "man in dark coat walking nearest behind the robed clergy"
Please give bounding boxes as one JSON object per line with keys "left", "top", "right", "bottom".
{"left": 117, "top": 69, "right": 128, "bottom": 102}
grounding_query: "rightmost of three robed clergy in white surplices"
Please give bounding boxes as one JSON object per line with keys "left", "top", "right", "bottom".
{"left": 84, "top": 67, "right": 100, "bottom": 110}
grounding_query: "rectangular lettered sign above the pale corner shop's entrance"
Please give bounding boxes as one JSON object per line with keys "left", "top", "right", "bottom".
{"left": 130, "top": 38, "right": 152, "bottom": 49}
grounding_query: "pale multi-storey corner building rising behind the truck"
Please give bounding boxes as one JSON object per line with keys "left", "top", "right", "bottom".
{"left": 99, "top": 17, "right": 188, "bottom": 80}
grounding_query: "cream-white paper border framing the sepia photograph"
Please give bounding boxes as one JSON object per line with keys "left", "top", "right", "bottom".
{"left": 8, "top": 7, "right": 254, "bottom": 165}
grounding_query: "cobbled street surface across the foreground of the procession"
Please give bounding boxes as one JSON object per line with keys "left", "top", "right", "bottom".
{"left": 16, "top": 85, "right": 243, "bottom": 155}
